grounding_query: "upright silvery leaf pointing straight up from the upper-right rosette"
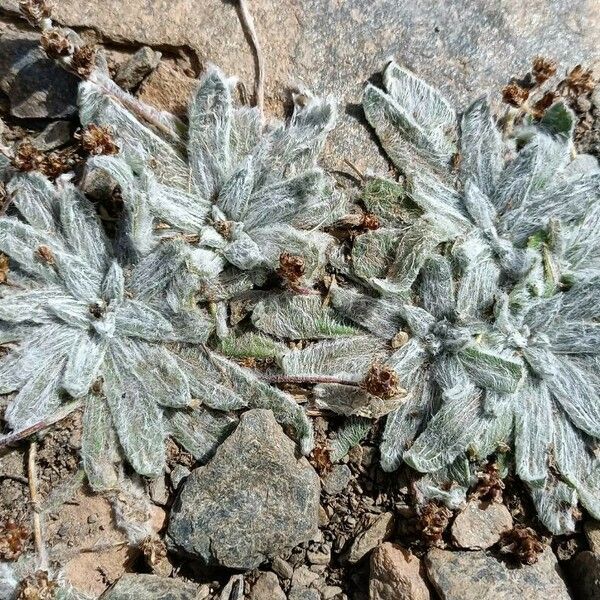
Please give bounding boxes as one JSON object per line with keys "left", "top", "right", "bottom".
{"left": 460, "top": 98, "right": 504, "bottom": 196}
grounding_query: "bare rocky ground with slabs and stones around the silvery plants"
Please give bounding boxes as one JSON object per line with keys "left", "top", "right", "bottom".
{"left": 0, "top": 0, "right": 600, "bottom": 600}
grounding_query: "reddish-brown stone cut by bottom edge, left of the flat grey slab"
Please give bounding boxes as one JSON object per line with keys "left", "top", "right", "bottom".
{"left": 369, "top": 542, "right": 430, "bottom": 600}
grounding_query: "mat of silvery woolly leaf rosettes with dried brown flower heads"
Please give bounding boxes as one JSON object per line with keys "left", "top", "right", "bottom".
{"left": 0, "top": 8, "right": 600, "bottom": 584}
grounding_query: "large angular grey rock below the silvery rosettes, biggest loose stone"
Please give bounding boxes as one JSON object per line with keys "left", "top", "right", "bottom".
{"left": 168, "top": 410, "right": 320, "bottom": 569}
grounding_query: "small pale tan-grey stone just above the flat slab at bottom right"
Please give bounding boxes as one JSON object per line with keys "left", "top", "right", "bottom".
{"left": 451, "top": 500, "right": 512, "bottom": 550}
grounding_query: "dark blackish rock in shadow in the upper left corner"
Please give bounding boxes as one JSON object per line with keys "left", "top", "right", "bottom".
{"left": 0, "top": 31, "right": 78, "bottom": 119}
